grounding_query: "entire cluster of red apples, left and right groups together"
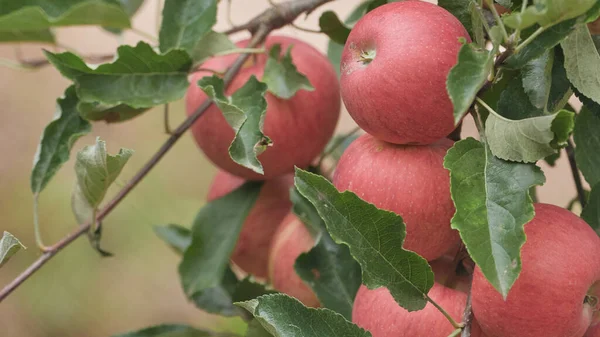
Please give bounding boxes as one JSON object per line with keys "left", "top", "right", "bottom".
{"left": 186, "top": 0, "right": 600, "bottom": 337}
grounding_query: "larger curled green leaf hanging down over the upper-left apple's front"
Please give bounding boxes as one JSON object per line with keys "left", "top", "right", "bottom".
{"left": 198, "top": 76, "right": 271, "bottom": 174}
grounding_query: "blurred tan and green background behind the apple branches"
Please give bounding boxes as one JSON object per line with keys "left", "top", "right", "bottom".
{"left": 0, "top": 0, "right": 575, "bottom": 337}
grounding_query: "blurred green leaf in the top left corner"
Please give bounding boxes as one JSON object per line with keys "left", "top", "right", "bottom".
{"left": 0, "top": 0, "right": 130, "bottom": 32}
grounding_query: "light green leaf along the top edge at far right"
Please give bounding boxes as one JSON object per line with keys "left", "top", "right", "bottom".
{"left": 503, "top": 0, "right": 596, "bottom": 29}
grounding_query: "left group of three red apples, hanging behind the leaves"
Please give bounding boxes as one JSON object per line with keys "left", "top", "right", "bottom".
{"left": 186, "top": 36, "right": 341, "bottom": 307}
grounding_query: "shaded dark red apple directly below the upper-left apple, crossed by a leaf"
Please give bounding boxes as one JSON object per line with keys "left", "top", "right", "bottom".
{"left": 207, "top": 171, "right": 294, "bottom": 279}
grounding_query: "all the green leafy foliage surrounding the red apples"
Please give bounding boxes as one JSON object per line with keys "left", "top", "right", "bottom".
{"left": 0, "top": 0, "right": 600, "bottom": 337}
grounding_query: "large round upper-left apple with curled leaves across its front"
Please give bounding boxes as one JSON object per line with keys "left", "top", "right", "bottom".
{"left": 186, "top": 36, "right": 341, "bottom": 180}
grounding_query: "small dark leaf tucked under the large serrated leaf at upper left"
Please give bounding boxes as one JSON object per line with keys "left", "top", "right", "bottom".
{"left": 77, "top": 102, "right": 149, "bottom": 123}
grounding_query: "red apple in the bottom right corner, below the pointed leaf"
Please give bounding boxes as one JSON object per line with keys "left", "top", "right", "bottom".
{"left": 472, "top": 204, "right": 600, "bottom": 337}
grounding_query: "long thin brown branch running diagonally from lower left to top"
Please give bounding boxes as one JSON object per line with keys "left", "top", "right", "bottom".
{"left": 0, "top": 0, "right": 332, "bottom": 302}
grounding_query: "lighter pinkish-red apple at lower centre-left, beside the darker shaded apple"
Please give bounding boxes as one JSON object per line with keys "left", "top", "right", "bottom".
{"left": 269, "top": 213, "right": 320, "bottom": 307}
